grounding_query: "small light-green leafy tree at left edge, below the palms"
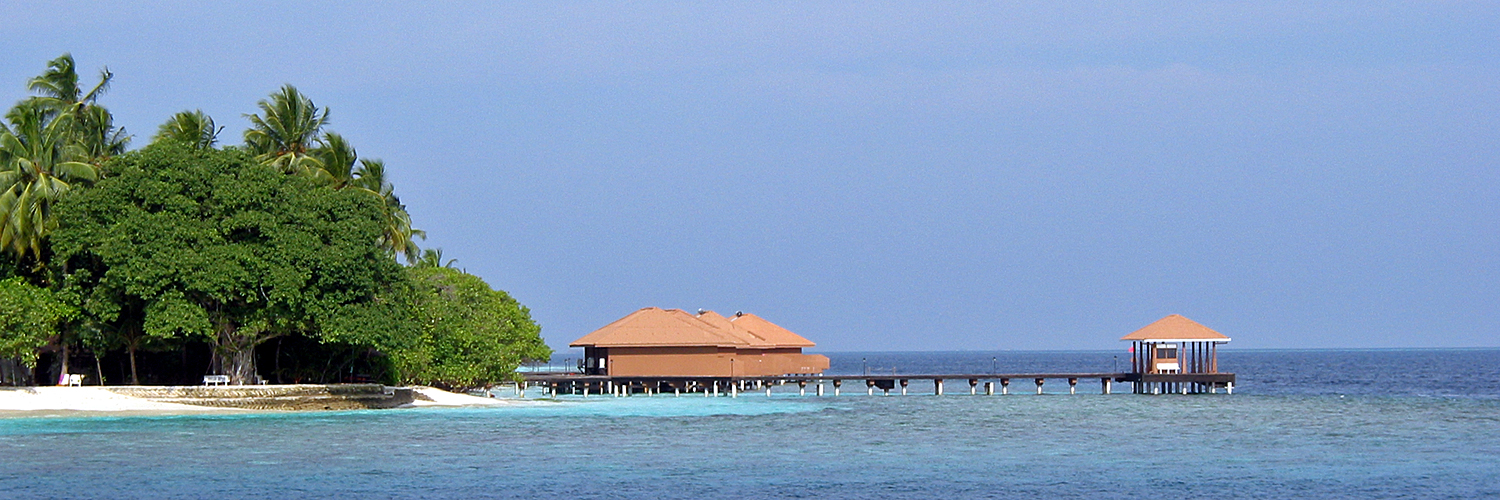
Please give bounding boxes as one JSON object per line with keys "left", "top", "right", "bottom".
{"left": 0, "top": 278, "right": 78, "bottom": 366}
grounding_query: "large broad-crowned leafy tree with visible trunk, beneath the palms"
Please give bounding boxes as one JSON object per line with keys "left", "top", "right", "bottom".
{"left": 53, "top": 143, "right": 402, "bottom": 384}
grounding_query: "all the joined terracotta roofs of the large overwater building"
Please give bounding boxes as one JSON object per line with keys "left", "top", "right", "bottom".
{"left": 569, "top": 308, "right": 816, "bottom": 348}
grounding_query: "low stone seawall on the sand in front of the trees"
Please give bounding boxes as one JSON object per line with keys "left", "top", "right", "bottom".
{"left": 107, "top": 384, "right": 414, "bottom": 410}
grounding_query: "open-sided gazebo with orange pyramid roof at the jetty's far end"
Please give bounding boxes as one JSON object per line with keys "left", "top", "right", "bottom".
{"left": 1121, "top": 314, "right": 1230, "bottom": 390}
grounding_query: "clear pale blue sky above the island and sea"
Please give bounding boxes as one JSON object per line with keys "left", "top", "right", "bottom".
{"left": 0, "top": 2, "right": 1500, "bottom": 351}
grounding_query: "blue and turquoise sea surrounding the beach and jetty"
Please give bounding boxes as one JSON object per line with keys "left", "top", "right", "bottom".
{"left": 0, "top": 350, "right": 1500, "bottom": 498}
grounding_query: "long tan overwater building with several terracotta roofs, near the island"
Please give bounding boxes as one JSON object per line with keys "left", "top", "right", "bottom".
{"left": 569, "top": 308, "right": 828, "bottom": 378}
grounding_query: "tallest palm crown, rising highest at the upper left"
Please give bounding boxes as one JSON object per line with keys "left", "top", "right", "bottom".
{"left": 27, "top": 54, "right": 131, "bottom": 165}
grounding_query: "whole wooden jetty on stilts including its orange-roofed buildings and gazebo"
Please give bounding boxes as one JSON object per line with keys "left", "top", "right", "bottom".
{"left": 516, "top": 308, "right": 1235, "bottom": 396}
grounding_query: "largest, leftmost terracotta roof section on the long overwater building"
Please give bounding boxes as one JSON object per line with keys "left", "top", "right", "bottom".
{"left": 569, "top": 308, "right": 750, "bottom": 347}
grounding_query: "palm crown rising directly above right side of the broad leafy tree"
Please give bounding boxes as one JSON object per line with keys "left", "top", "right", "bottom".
{"left": 245, "top": 84, "right": 332, "bottom": 179}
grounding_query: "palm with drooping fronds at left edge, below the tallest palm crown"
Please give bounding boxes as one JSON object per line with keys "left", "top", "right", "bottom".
{"left": 0, "top": 99, "right": 99, "bottom": 258}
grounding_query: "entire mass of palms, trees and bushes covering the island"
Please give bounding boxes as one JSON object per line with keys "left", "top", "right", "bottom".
{"left": 0, "top": 56, "right": 551, "bottom": 387}
